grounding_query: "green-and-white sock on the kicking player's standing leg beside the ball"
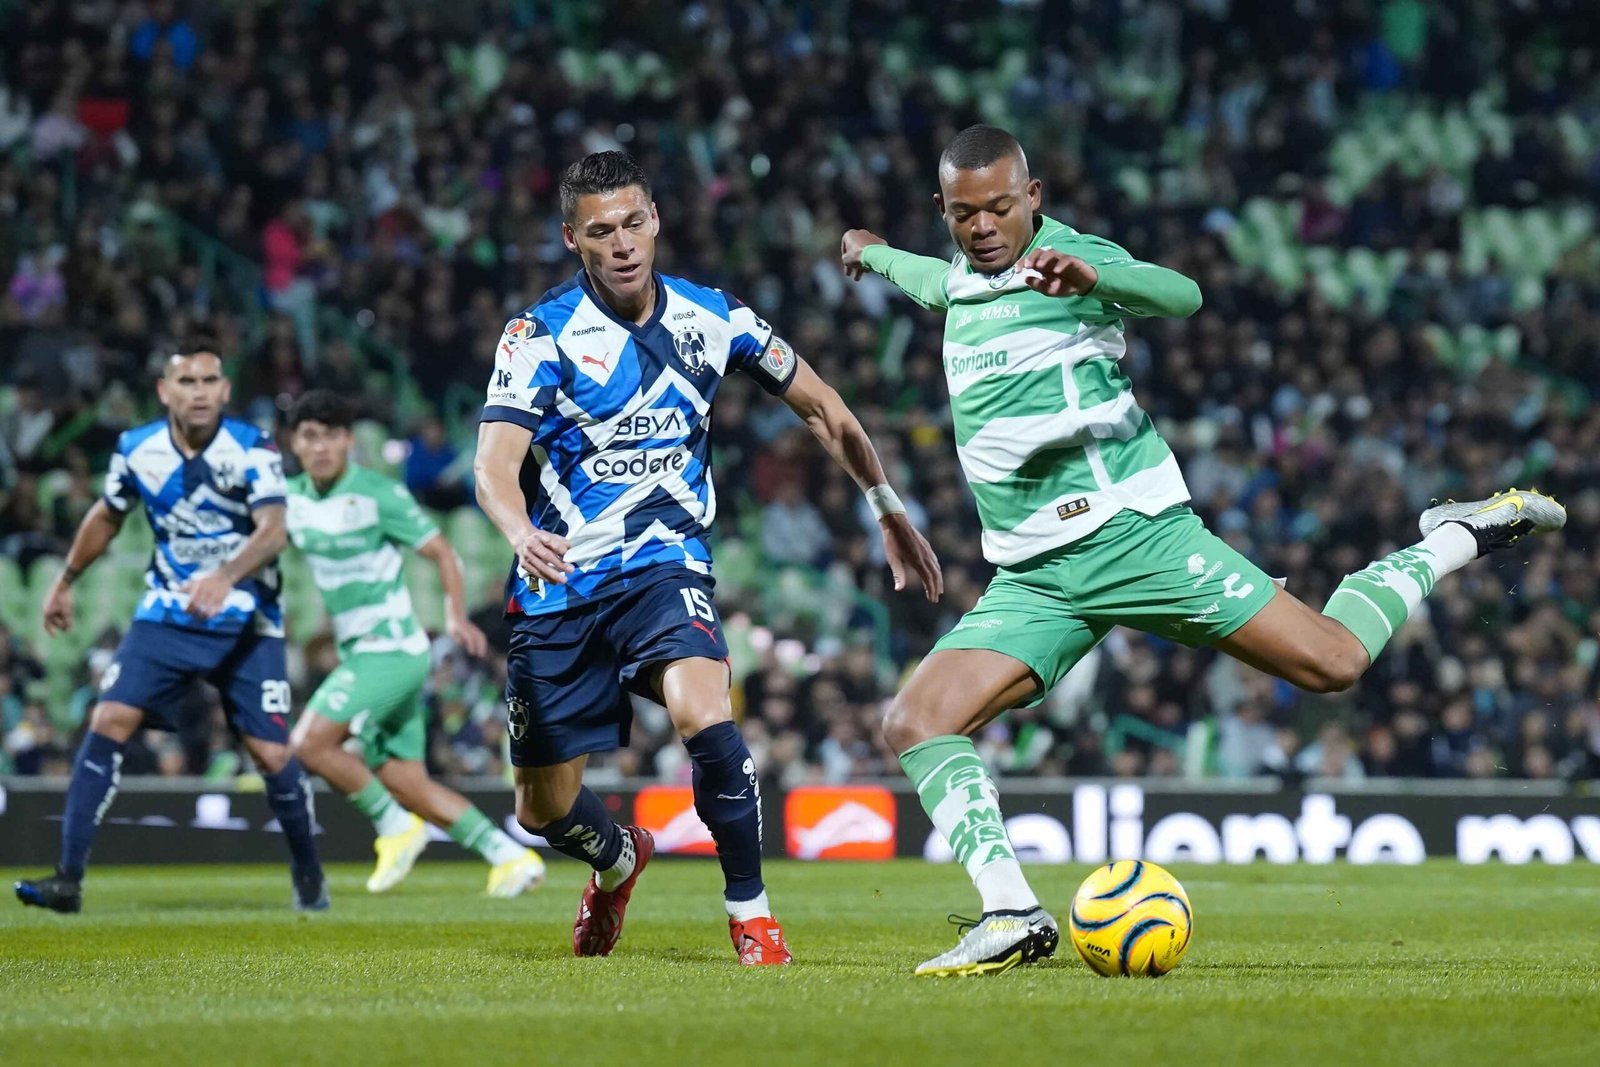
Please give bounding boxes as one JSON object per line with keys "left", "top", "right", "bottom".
{"left": 901, "top": 734, "right": 1038, "bottom": 912}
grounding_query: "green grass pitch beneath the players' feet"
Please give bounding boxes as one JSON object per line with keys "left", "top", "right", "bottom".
{"left": 0, "top": 861, "right": 1600, "bottom": 1067}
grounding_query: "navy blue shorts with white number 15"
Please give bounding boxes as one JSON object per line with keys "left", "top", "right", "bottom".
{"left": 506, "top": 565, "right": 728, "bottom": 766}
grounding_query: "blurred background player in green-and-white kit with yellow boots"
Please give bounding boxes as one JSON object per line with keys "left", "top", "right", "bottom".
{"left": 288, "top": 390, "right": 544, "bottom": 897}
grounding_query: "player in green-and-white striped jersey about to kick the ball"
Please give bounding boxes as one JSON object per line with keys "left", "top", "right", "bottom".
{"left": 842, "top": 126, "right": 1566, "bottom": 976}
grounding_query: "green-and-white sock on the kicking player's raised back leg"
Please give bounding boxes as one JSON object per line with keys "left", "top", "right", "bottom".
{"left": 1322, "top": 523, "right": 1477, "bottom": 659}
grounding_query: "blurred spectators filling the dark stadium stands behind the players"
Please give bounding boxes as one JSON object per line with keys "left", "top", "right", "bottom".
{"left": 0, "top": 0, "right": 1600, "bottom": 782}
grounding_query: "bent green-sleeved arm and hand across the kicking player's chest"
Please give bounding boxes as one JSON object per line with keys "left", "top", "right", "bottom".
{"left": 1016, "top": 235, "right": 1200, "bottom": 320}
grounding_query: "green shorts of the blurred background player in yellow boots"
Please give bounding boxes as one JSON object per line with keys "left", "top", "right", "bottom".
{"left": 306, "top": 653, "right": 429, "bottom": 769}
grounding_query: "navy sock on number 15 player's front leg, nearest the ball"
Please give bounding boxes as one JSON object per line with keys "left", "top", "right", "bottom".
{"left": 683, "top": 723, "right": 766, "bottom": 901}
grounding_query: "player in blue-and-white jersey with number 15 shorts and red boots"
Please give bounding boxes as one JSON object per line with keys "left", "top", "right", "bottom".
{"left": 477, "top": 152, "right": 942, "bottom": 965}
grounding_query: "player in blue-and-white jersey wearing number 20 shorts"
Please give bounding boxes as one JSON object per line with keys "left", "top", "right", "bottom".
{"left": 16, "top": 338, "right": 328, "bottom": 912}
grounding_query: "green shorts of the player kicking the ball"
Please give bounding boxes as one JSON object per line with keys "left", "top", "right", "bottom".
{"left": 933, "top": 506, "right": 1277, "bottom": 697}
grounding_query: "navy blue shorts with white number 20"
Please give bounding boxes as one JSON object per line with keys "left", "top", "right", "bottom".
{"left": 99, "top": 621, "right": 290, "bottom": 744}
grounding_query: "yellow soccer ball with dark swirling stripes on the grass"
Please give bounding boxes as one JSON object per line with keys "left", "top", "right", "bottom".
{"left": 1069, "top": 859, "right": 1194, "bottom": 977}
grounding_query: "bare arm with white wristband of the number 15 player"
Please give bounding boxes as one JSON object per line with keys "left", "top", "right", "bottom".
{"left": 784, "top": 360, "right": 944, "bottom": 600}
